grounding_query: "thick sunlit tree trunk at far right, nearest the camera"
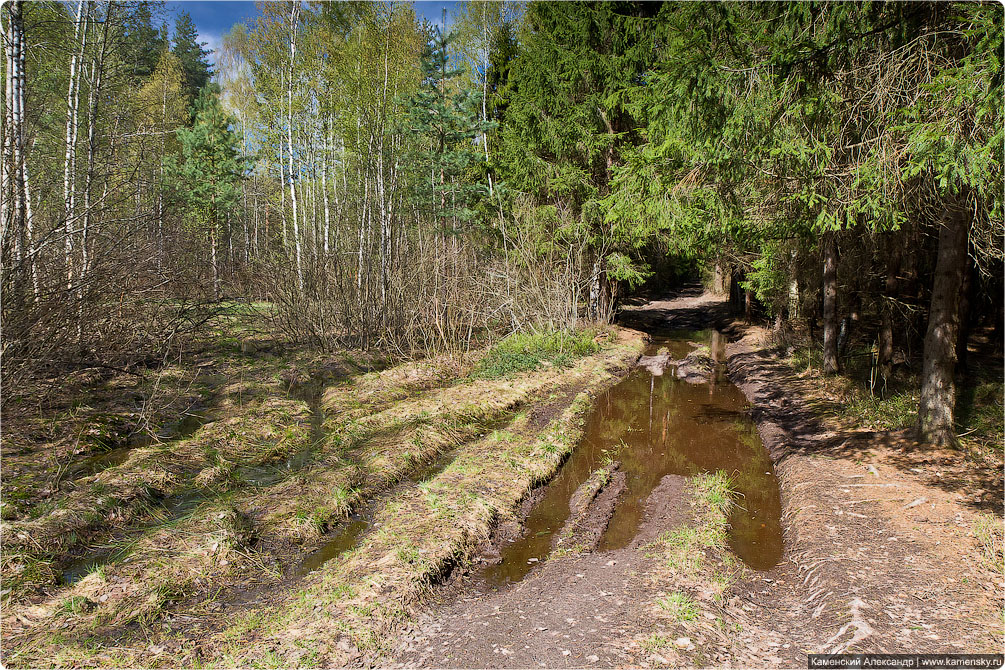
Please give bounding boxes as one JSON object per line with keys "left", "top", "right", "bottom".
{"left": 918, "top": 204, "right": 968, "bottom": 445}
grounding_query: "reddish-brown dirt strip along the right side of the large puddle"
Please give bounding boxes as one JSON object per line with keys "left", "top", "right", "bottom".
{"left": 728, "top": 328, "right": 1005, "bottom": 663}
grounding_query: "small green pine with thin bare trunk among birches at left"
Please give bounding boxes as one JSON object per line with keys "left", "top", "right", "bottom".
{"left": 169, "top": 84, "right": 245, "bottom": 298}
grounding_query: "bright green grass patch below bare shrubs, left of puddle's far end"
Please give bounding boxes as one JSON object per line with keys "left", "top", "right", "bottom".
{"left": 471, "top": 330, "right": 600, "bottom": 379}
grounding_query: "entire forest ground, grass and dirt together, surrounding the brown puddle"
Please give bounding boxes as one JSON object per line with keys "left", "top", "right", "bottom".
{"left": 0, "top": 291, "right": 1005, "bottom": 667}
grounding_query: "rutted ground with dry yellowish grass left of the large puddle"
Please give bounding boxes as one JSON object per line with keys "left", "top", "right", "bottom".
{"left": 0, "top": 312, "right": 645, "bottom": 667}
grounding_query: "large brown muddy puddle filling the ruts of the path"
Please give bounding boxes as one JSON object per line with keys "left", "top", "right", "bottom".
{"left": 475, "top": 330, "right": 783, "bottom": 588}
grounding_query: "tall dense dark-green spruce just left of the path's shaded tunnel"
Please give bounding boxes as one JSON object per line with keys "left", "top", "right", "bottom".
{"left": 489, "top": 2, "right": 671, "bottom": 284}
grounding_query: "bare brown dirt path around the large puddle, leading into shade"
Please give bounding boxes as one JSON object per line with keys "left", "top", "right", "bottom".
{"left": 381, "top": 288, "right": 1005, "bottom": 667}
